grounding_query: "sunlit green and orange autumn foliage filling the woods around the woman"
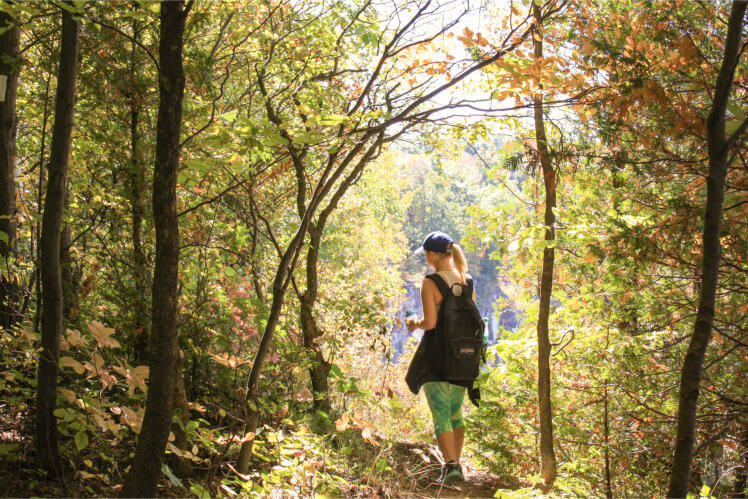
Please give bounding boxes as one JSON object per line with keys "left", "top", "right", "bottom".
{"left": 0, "top": 0, "right": 748, "bottom": 497}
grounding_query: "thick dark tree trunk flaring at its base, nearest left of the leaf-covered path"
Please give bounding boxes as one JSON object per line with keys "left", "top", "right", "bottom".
{"left": 120, "top": 1, "right": 189, "bottom": 497}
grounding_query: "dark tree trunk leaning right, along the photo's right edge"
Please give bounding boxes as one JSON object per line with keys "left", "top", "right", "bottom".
{"left": 667, "top": 1, "right": 746, "bottom": 497}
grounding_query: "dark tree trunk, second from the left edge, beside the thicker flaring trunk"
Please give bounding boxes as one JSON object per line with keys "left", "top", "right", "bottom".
{"left": 36, "top": 6, "right": 80, "bottom": 474}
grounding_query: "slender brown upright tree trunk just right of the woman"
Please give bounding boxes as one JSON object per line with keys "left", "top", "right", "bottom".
{"left": 533, "top": 3, "right": 556, "bottom": 491}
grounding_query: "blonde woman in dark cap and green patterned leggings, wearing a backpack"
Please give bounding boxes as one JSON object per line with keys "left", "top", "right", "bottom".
{"left": 405, "top": 232, "right": 483, "bottom": 485}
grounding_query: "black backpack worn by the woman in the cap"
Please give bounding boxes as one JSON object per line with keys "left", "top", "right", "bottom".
{"left": 428, "top": 274, "right": 486, "bottom": 382}
